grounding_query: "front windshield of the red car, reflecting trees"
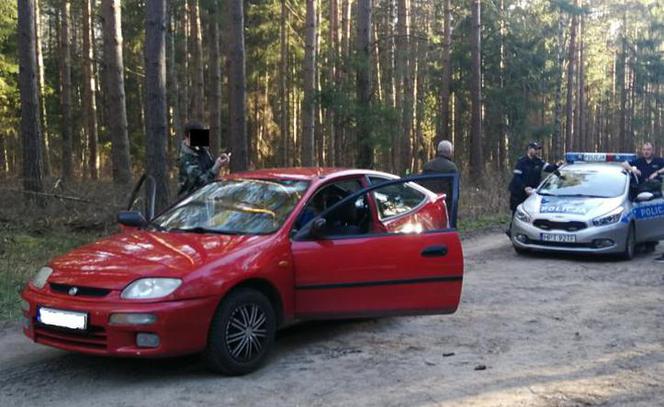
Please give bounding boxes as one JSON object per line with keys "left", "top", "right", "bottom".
{"left": 151, "top": 179, "right": 309, "bottom": 234}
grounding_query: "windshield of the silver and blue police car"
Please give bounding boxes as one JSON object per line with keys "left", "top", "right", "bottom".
{"left": 537, "top": 169, "right": 627, "bottom": 198}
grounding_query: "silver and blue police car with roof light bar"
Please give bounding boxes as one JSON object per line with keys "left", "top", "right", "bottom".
{"left": 511, "top": 153, "right": 664, "bottom": 259}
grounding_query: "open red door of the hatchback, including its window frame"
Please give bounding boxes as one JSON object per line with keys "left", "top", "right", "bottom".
{"left": 291, "top": 175, "right": 463, "bottom": 318}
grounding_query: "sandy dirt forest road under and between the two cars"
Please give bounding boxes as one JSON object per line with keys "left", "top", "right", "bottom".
{"left": 0, "top": 234, "right": 664, "bottom": 407}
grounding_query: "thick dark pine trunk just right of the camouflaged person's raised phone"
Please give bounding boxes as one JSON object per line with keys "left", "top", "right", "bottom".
{"left": 228, "top": 0, "right": 249, "bottom": 171}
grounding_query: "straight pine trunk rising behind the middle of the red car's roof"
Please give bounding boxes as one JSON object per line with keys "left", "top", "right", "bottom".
{"left": 302, "top": 0, "right": 317, "bottom": 167}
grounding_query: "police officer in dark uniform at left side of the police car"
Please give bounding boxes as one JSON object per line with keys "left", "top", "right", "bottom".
{"left": 509, "top": 142, "right": 562, "bottom": 215}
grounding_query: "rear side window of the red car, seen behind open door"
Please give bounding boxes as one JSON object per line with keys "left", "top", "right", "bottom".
{"left": 369, "top": 177, "right": 426, "bottom": 220}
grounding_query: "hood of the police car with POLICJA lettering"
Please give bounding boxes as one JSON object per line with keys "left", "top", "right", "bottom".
{"left": 523, "top": 194, "right": 623, "bottom": 221}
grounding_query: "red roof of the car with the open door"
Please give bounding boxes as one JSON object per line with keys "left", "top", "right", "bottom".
{"left": 220, "top": 167, "right": 398, "bottom": 181}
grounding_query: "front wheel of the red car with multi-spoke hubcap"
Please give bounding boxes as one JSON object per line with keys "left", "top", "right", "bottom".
{"left": 203, "top": 288, "right": 277, "bottom": 376}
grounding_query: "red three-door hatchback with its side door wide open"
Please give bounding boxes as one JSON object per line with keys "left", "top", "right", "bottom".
{"left": 22, "top": 168, "right": 463, "bottom": 374}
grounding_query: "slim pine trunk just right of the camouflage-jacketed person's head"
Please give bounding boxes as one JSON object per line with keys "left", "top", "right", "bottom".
{"left": 208, "top": 0, "right": 222, "bottom": 155}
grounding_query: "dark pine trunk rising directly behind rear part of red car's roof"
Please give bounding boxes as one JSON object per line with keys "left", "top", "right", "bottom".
{"left": 357, "top": 0, "right": 373, "bottom": 168}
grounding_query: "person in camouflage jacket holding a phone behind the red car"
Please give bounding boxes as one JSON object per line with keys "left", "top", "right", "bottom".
{"left": 178, "top": 122, "right": 230, "bottom": 196}
